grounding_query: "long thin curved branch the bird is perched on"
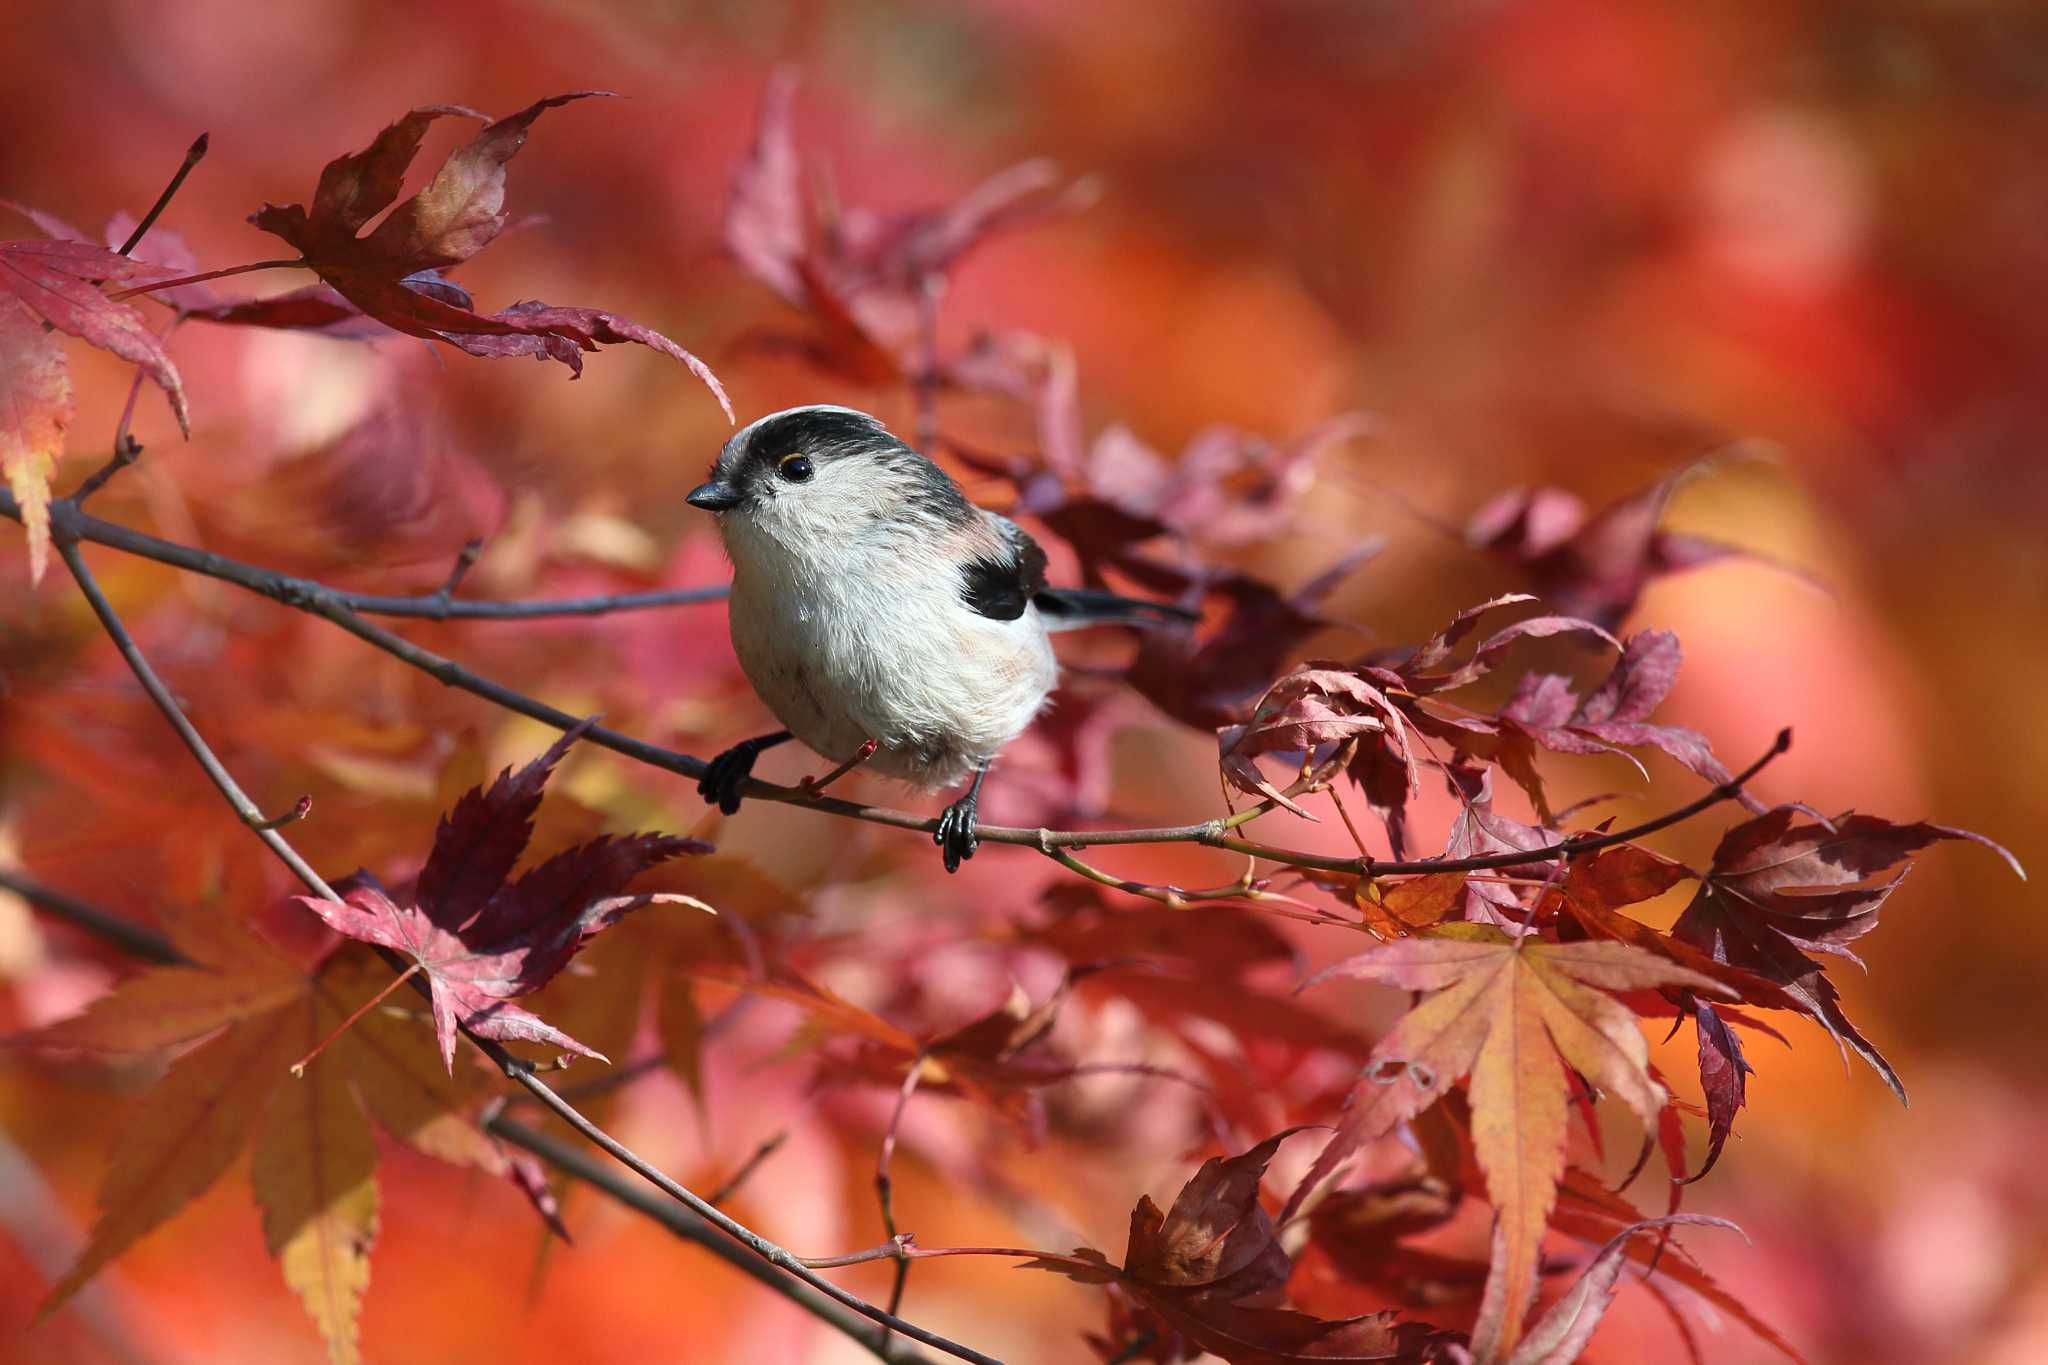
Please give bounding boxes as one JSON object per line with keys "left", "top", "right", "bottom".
{"left": 16, "top": 491, "right": 1792, "bottom": 878}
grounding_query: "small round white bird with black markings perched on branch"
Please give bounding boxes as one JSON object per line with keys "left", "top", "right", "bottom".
{"left": 688, "top": 405, "right": 1196, "bottom": 872}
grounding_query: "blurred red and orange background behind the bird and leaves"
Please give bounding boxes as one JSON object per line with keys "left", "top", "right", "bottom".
{"left": 0, "top": 0, "right": 2048, "bottom": 1363}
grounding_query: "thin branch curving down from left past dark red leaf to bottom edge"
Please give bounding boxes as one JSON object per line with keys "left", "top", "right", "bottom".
{"left": 51, "top": 527, "right": 999, "bottom": 1365}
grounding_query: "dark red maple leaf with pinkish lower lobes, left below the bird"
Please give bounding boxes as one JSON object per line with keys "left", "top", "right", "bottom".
{"left": 299, "top": 726, "right": 711, "bottom": 1070}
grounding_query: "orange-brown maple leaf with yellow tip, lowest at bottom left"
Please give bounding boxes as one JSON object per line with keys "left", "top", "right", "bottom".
{"left": 25, "top": 915, "right": 512, "bottom": 1365}
